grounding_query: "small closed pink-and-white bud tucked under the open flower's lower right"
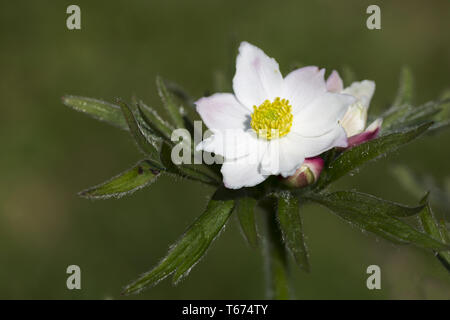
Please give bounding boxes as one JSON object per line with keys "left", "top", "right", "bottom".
{"left": 281, "top": 157, "right": 324, "bottom": 188}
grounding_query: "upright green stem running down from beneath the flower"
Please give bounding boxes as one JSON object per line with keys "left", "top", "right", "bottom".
{"left": 262, "top": 201, "right": 290, "bottom": 300}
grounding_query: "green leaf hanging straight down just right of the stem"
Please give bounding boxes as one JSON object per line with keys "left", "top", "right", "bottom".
{"left": 278, "top": 192, "right": 310, "bottom": 272}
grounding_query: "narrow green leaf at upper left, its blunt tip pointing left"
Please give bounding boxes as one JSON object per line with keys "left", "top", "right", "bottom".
{"left": 62, "top": 95, "right": 128, "bottom": 130}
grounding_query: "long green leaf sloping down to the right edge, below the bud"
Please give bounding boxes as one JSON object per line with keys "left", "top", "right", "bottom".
{"left": 309, "top": 191, "right": 449, "bottom": 251}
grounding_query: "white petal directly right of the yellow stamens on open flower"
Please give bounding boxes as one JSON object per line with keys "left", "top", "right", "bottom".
{"left": 291, "top": 92, "right": 355, "bottom": 137}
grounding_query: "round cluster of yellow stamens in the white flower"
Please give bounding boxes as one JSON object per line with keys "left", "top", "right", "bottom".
{"left": 250, "top": 97, "right": 293, "bottom": 140}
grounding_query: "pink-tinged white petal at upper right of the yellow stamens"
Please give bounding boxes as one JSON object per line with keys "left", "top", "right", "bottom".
{"left": 282, "top": 66, "right": 327, "bottom": 115}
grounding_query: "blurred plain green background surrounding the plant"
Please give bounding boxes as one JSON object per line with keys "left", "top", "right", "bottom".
{"left": 0, "top": 0, "right": 450, "bottom": 299}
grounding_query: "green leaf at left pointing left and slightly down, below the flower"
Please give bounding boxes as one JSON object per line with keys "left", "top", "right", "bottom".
{"left": 79, "top": 160, "right": 161, "bottom": 199}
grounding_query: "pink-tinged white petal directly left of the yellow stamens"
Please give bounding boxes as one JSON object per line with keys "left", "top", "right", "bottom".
{"left": 195, "top": 93, "right": 250, "bottom": 130}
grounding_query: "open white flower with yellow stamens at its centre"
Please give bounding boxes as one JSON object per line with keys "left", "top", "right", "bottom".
{"left": 196, "top": 42, "right": 355, "bottom": 189}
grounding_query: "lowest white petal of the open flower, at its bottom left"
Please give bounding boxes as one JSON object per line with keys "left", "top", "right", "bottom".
{"left": 220, "top": 153, "right": 268, "bottom": 189}
